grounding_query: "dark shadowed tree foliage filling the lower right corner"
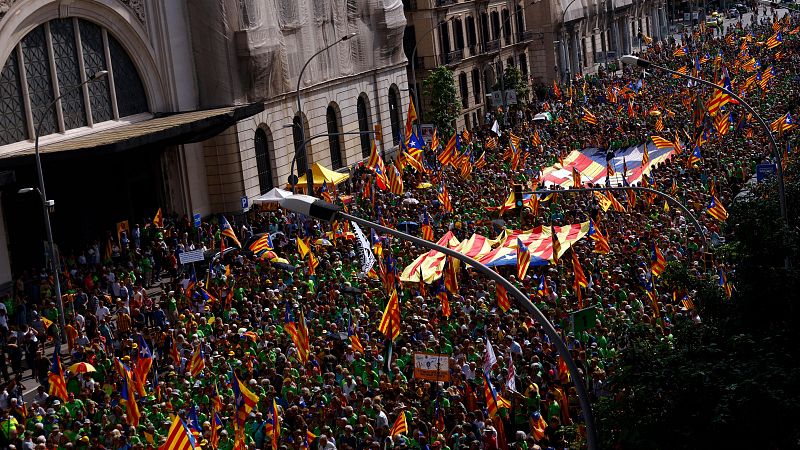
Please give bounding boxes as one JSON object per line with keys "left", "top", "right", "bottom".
{"left": 595, "top": 160, "right": 800, "bottom": 449}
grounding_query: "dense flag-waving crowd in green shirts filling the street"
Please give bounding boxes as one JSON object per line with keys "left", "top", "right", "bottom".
{"left": 0, "top": 6, "right": 800, "bottom": 450}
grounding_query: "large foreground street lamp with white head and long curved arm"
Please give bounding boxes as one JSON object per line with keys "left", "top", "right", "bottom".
{"left": 281, "top": 195, "right": 597, "bottom": 450}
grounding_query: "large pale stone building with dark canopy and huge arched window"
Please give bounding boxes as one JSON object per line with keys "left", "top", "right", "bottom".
{"left": 0, "top": 0, "right": 408, "bottom": 283}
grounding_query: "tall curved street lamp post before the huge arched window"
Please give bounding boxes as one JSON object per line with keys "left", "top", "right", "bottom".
{"left": 19, "top": 70, "right": 108, "bottom": 351}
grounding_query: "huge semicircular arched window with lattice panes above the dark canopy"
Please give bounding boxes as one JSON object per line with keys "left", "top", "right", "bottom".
{"left": 0, "top": 18, "right": 148, "bottom": 145}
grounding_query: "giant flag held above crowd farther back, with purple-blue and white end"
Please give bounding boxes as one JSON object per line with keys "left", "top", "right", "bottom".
{"left": 541, "top": 142, "right": 675, "bottom": 189}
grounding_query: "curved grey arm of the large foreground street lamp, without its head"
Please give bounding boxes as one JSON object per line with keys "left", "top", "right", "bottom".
{"left": 337, "top": 211, "right": 597, "bottom": 450}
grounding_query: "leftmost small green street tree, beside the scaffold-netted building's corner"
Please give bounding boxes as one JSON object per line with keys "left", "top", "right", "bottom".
{"left": 423, "top": 66, "right": 461, "bottom": 140}
